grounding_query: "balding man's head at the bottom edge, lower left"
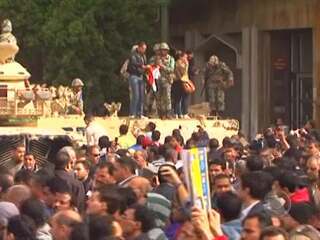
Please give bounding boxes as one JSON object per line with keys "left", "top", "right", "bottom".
{"left": 50, "top": 210, "right": 82, "bottom": 240}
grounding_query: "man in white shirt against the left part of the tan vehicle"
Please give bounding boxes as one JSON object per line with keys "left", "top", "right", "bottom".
{"left": 84, "top": 115, "right": 106, "bottom": 146}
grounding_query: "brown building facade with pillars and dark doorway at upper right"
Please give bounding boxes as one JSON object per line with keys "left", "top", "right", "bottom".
{"left": 170, "top": 0, "right": 320, "bottom": 136}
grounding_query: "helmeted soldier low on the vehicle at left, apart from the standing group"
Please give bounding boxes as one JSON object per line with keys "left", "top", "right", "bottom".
{"left": 68, "top": 78, "right": 84, "bottom": 115}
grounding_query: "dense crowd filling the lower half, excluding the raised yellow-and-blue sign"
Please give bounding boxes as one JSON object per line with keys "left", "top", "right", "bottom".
{"left": 0, "top": 119, "right": 320, "bottom": 240}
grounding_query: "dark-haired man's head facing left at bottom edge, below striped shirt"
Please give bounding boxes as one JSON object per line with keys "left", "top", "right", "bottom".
{"left": 122, "top": 205, "right": 155, "bottom": 238}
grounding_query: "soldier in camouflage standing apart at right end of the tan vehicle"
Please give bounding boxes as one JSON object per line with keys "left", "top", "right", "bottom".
{"left": 204, "top": 55, "right": 233, "bottom": 116}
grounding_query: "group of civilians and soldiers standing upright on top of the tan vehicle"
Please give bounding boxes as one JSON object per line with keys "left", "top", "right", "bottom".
{"left": 121, "top": 42, "right": 233, "bottom": 119}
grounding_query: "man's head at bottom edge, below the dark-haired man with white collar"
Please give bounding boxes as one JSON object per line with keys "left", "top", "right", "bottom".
{"left": 241, "top": 212, "right": 272, "bottom": 240}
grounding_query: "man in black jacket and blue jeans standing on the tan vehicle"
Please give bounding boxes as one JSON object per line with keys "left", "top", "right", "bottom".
{"left": 127, "top": 42, "right": 147, "bottom": 118}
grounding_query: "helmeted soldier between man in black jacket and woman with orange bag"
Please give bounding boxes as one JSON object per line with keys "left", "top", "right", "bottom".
{"left": 156, "top": 43, "right": 175, "bottom": 119}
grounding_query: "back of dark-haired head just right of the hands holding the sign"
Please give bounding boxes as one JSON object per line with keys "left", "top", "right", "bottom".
{"left": 217, "top": 191, "right": 242, "bottom": 222}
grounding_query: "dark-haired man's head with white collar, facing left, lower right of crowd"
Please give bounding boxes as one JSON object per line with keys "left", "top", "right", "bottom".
{"left": 239, "top": 171, "right": 272, "bottom": 219}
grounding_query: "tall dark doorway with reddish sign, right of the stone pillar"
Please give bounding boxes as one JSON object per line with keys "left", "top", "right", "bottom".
{"left": 270, "top": 29, "right": 313, "bottom": 129}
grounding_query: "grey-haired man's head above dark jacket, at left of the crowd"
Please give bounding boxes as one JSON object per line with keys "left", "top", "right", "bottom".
{"left": 54, "top": 146, "right": 77, "bottom": 172}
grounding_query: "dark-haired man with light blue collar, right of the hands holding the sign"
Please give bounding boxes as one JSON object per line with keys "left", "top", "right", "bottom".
{"left": 216, "top": 192, "right": 242, "bottom": 239}
